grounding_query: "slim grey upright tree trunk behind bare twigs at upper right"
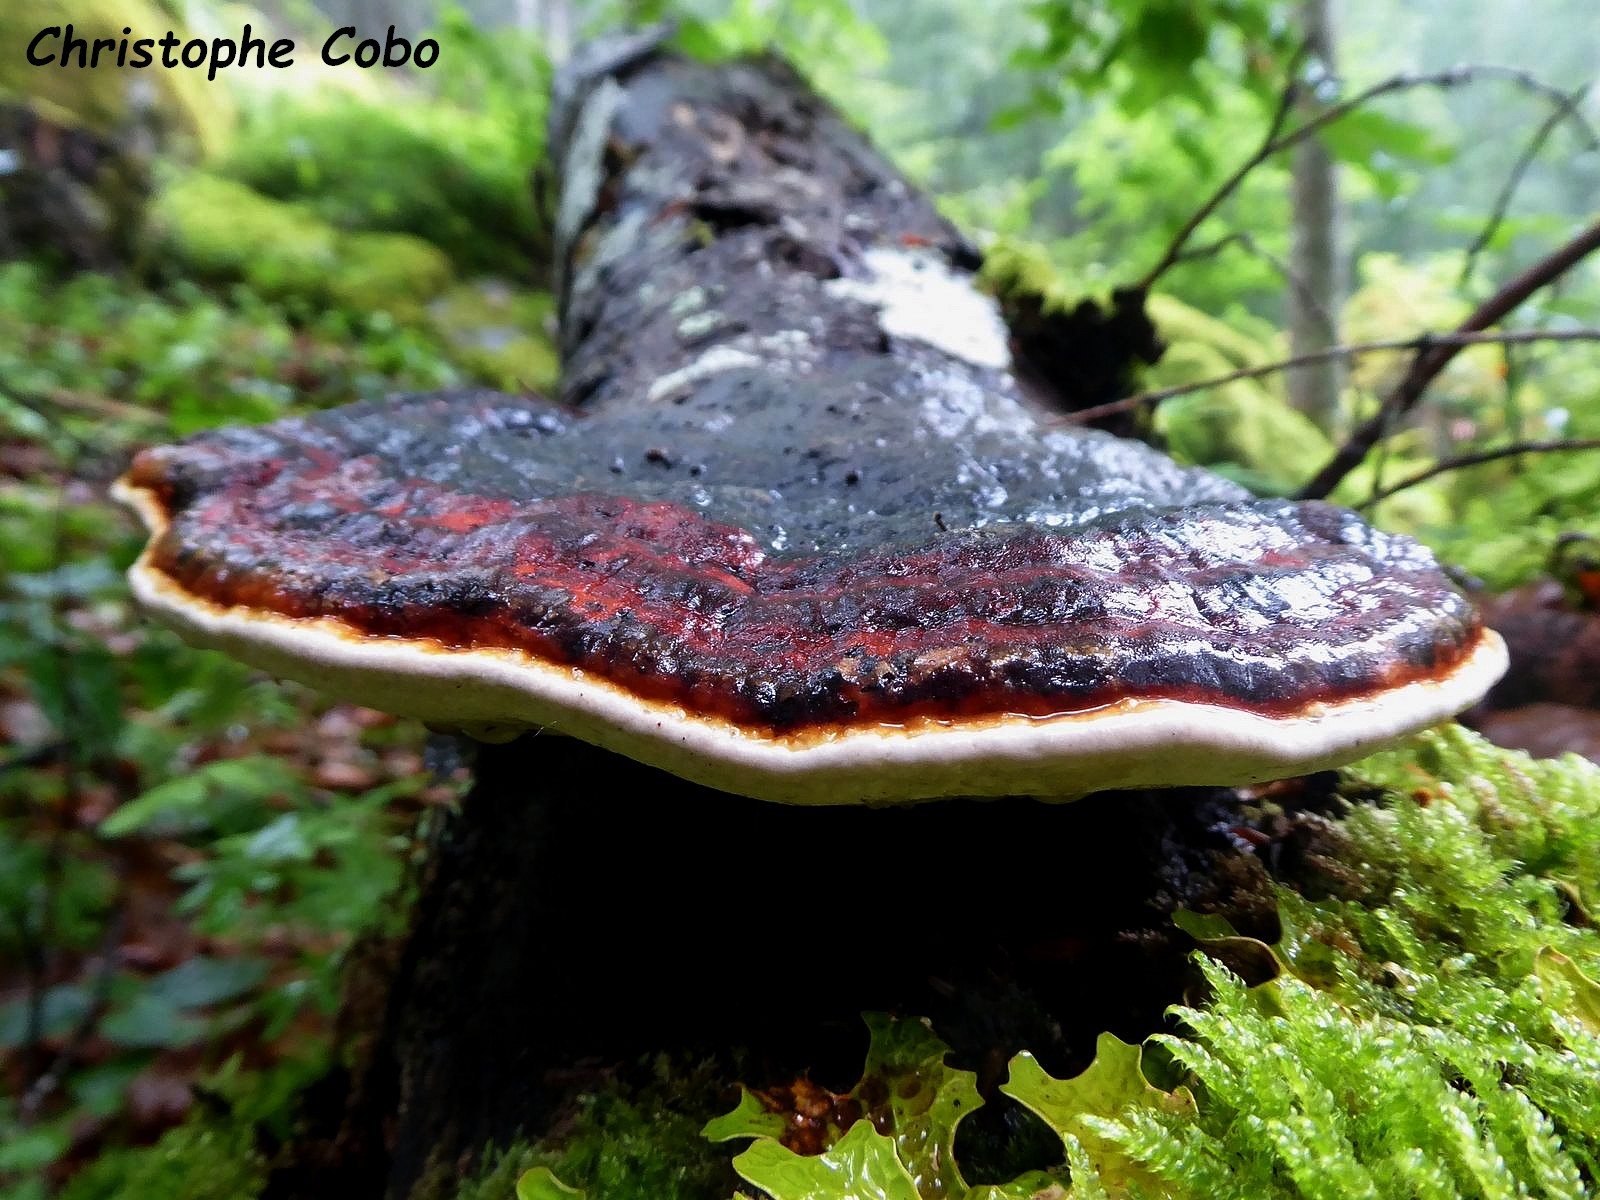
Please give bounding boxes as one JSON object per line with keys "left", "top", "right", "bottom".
{"left": 1288, "top": 0, "right": 1346, "bottom": 430}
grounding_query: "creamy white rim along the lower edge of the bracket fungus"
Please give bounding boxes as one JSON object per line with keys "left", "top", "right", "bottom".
{"left": 112, "top": 482, "right": 1507, "bottom": 805}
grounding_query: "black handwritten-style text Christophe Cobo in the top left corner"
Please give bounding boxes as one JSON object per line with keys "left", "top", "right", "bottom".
{"left": 27, "top": 26, "right": 438, "bottom": 78}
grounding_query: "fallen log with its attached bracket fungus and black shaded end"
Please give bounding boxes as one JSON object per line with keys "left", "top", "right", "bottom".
{"left": 125, "top": 32, "right": 1501, "bottom": 1197}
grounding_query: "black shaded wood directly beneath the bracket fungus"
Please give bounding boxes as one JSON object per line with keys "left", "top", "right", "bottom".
{"left": 308, "top": 738, "right": 1272, "bottom": 1197}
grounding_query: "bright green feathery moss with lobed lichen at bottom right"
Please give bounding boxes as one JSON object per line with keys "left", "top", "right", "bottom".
{"left": 710, "top": 726, "right": 1600, "bottom": 1200}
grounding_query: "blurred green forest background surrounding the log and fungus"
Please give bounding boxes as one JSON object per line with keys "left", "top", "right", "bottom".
{"left": 0, "top": 0, "right": 1600, "bottom": 1197}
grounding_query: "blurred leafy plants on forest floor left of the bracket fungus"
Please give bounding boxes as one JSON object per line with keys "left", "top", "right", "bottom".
{"left": 0, "top": 254, "right": 480, "bottom": 1195}
